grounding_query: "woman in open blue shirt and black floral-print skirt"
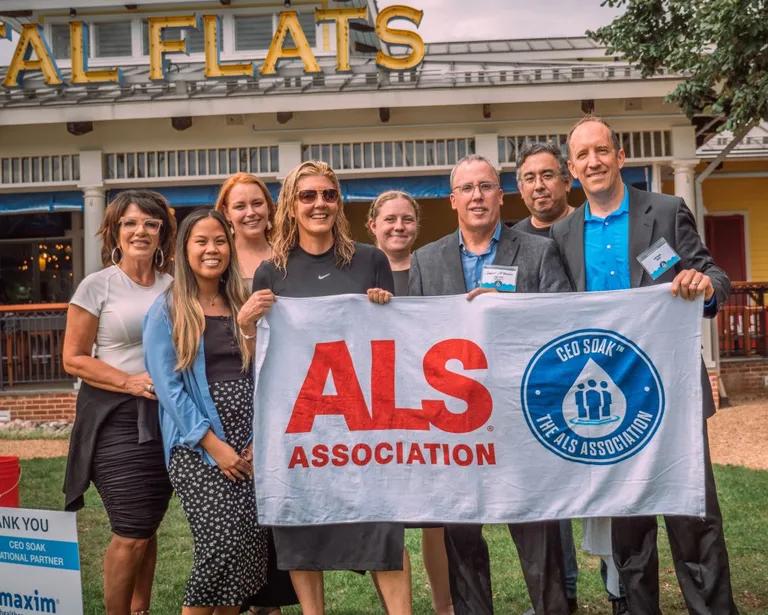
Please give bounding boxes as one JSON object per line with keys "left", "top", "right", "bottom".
{"left": 144, "top": 210, "right": 267, "bottom": 615}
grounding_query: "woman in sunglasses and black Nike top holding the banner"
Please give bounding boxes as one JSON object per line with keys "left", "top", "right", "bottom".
{"left": 244, "top": 161, "right": 411, "bottom": 615}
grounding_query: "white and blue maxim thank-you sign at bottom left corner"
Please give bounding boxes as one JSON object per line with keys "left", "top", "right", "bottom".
{"left": 0, "top": 508, "right": 83, "bottom": 615}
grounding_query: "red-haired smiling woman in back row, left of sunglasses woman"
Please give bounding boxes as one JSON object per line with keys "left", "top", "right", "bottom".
{"left": 216, "top": 173, "right": 275, "bottom": 290}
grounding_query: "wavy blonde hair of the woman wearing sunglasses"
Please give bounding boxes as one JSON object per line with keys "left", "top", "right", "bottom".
{"left": 272, "top": 160, "right": 355, "bottom": 273}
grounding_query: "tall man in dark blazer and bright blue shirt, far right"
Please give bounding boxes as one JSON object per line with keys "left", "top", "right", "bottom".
{"left": 551, "top": 116, "right": 738, "bottom": 615}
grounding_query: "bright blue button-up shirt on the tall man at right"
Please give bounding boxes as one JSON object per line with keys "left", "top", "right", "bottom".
{"left": 584, "top": 185, "right": 631, "bottom": 290}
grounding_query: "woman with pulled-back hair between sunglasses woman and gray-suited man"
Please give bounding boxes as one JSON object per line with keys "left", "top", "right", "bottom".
{"left": 366, "top": 190, "right": 453, "bottom": 615}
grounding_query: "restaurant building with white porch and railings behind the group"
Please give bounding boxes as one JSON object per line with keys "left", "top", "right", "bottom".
{"left": 0, "top": 0, "right": 744, "bottom": 412}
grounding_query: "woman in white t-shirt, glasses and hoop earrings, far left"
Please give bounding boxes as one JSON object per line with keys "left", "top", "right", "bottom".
{"left": 62, "top": 190, "right": 176, "bottom": 615}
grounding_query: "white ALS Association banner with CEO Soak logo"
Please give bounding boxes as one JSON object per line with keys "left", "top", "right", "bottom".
{"left": 254, "top": 285, "right": 704, "bottom": 525}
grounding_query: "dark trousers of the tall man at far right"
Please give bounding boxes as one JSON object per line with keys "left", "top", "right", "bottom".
{"left": 611, "top": 421, "right": 739, "bottom": 615}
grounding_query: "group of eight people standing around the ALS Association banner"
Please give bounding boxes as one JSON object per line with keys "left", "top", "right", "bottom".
{"left": 63, "top": 116, "right": 738, "bottom": 615}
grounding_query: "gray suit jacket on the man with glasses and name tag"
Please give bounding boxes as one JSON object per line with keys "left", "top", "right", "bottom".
{"left": 408, "top": 225, "right": 572, "bottom": 296}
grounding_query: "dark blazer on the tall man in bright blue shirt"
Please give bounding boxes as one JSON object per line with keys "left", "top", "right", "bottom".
{"left": 551, "top": 187, "right": 731, "bottom": 416}
